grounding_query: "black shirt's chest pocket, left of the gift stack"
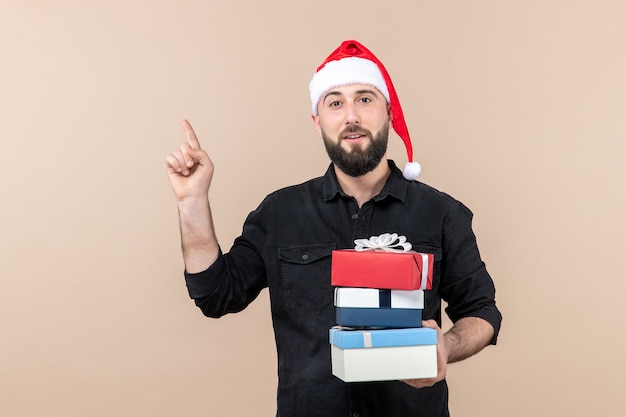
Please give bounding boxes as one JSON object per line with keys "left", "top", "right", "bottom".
{"left": 278, "top": 242, "right": 336, "bottom": 326}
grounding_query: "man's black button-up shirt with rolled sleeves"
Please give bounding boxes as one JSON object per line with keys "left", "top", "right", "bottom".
{"left": 186, "top": 161, "right": 501, "bottom": 417}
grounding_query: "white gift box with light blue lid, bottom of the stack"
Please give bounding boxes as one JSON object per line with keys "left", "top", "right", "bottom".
{"left": 329, "top": 327, "right": 437, "bottom": 382}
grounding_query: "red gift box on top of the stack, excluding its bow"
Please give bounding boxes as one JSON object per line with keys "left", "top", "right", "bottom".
{"left": 330, "top": 249, "right": 435, "bottom": 290}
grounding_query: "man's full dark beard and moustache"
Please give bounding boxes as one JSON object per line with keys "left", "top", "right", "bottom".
{"left": 322, "top": 123, "right": 389, "bottom": 177}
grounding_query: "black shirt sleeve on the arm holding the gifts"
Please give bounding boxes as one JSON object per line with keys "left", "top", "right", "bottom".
{"left": 441, "top": 202, "right": 502, "bottom": 344}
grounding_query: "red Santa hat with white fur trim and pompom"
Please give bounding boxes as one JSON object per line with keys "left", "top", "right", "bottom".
{"left": 309, "top": 40, "right": 422, "bottom": 180}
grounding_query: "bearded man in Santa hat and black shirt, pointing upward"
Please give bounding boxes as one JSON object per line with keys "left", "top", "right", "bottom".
{"left": 167, "top": 41, "right": 501, "bottom": 417}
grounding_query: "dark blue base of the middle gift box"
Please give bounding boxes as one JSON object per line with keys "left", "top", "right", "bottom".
{"left": 335, "top": 307, "right": 422, "bottom": 328}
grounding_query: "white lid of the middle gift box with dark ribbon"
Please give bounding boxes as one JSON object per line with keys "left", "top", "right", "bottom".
{"left": 335, "top": 287, "right": 424, "bottom": 308}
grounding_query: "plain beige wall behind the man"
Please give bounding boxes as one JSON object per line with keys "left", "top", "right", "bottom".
{"left": 0, "top": 0, "right": 626, "bottom": 417}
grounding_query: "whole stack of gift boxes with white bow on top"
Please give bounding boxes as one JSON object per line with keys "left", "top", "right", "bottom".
{"left": 329, "top": 234, "right": 437, "bottom": 382}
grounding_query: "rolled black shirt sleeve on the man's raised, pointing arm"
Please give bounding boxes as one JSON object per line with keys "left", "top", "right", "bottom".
{"left": 180, "top": 198, "right": 267, "bottom": 318}
